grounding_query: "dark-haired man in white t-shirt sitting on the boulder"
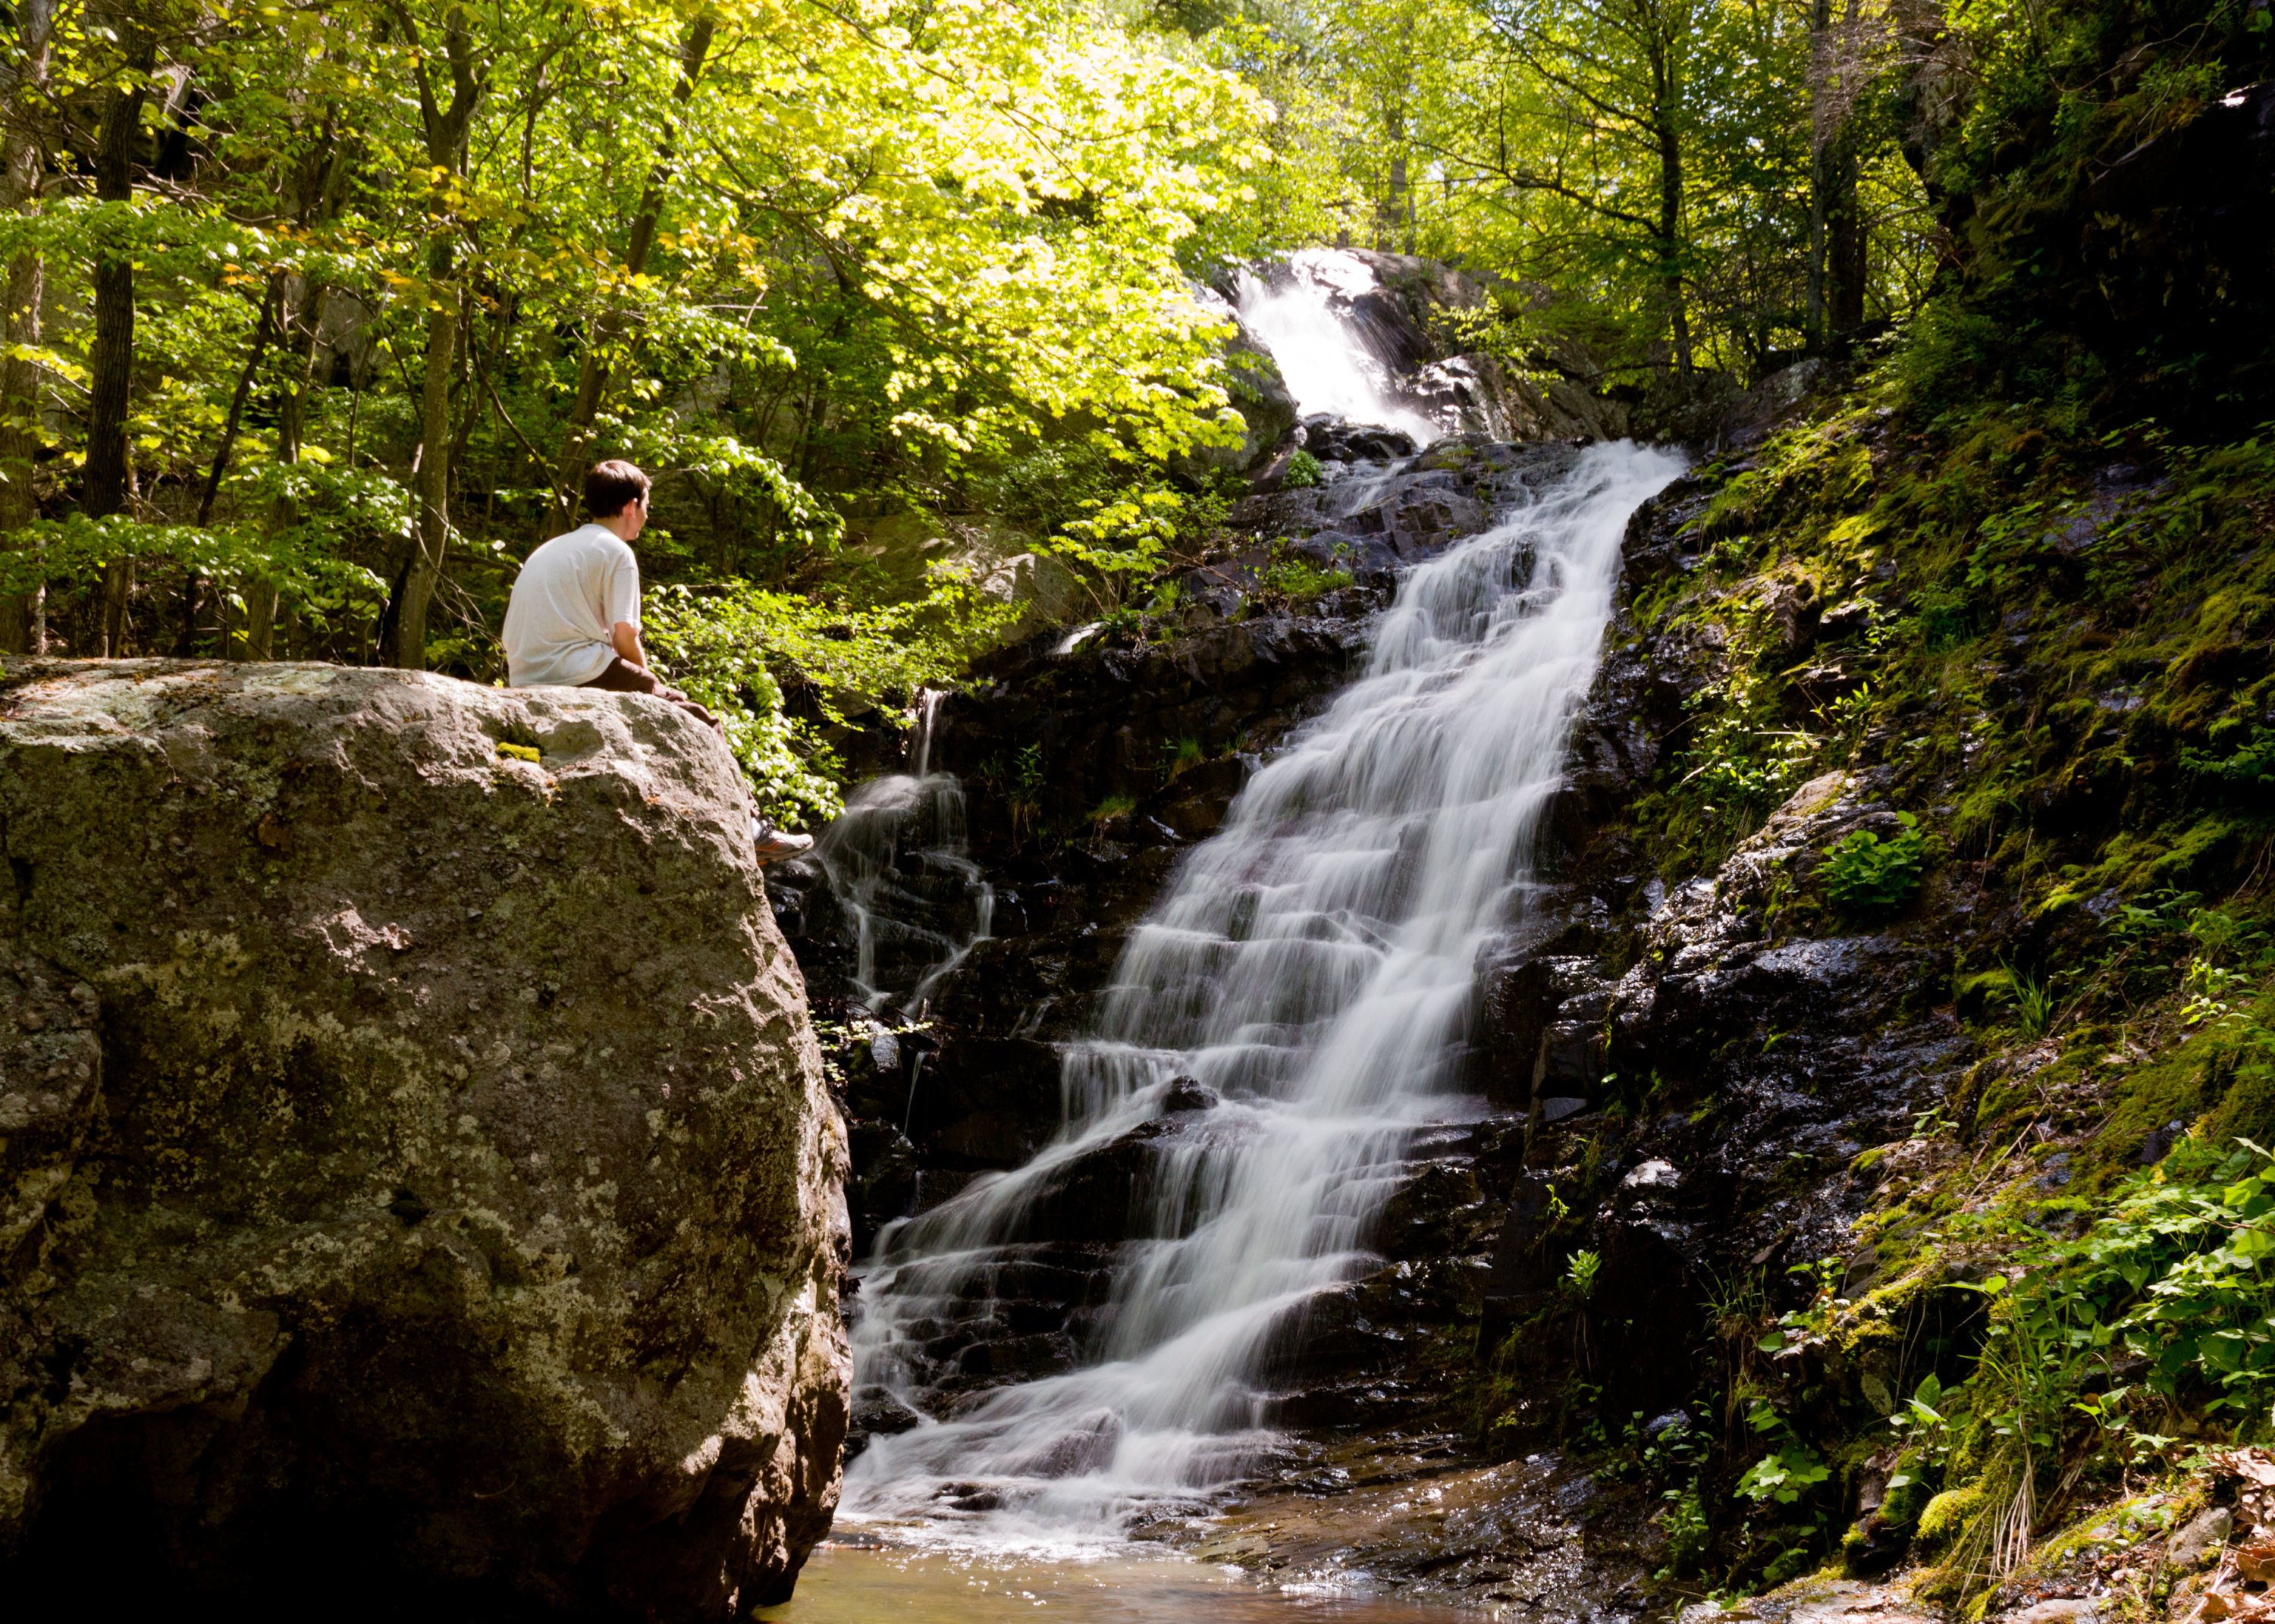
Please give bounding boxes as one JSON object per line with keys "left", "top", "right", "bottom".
{"left": 505, "top": 459, "right": 814, "bottom": 862}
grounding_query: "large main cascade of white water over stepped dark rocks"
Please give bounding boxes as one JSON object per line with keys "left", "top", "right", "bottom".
{"left": 844, "top": 444, "right": 1681, "bottom": 1538}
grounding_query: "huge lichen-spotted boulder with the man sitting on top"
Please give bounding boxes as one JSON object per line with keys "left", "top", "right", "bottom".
{"left": 0, "top": 660, "right": 849, "bottom": 1619}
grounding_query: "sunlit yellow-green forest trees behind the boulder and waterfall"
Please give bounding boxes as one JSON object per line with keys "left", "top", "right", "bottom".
{"left": 0, "top": 0, "right": 2268, "bottom": 819}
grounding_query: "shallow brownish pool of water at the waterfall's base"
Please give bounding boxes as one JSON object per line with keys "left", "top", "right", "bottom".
{"left": 755, "top": 1542, "right": 1513, "bottom": 1624}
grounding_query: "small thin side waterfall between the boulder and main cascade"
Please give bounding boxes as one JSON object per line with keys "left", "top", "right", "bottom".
{"left": 812, "top": 689, "right": 994, "bottom": 1017}
